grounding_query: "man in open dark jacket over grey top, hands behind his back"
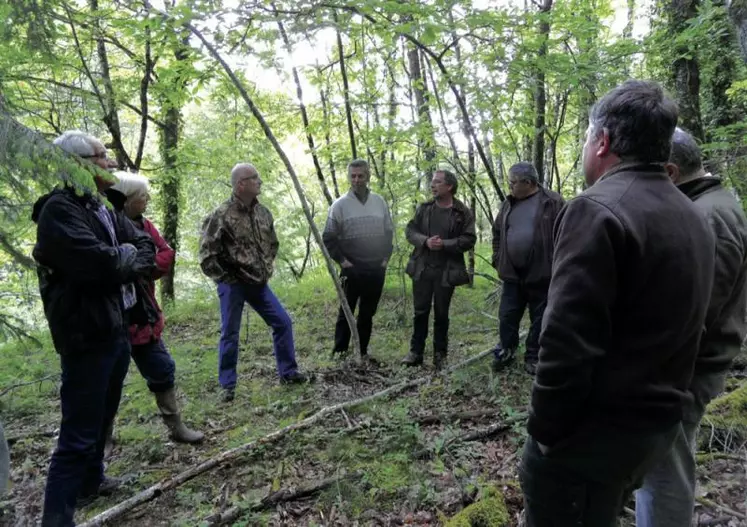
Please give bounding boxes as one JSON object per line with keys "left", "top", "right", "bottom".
{"left": 493, "top": 162, "right": 563, "bottom": 375}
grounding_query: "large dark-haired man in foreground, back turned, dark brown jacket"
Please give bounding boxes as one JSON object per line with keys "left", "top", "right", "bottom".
{"left": 519, "top": 81, "right": 714, "bottom": 527}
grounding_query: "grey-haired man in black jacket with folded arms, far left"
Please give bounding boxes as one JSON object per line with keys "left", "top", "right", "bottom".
{"left": 32, "top": 131, "right": 155, "bottom": 527}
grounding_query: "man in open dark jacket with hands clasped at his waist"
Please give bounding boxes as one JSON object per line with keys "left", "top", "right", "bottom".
{"left": 402, "top": 170, "right": 477, "bottom": 370}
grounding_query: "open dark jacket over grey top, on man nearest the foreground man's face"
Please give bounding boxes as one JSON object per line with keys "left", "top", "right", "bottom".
{"left": 492, "top": 187, "right": 563, "bottom": 284}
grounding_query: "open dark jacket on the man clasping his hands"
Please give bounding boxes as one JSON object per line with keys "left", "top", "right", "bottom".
{"left": 405, "top": 199, "right": 477, "bottom": 286}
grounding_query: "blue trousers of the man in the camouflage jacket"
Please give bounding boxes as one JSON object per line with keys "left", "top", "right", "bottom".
{"left": 218, "top": 282, "right": 298, "bottom": 388}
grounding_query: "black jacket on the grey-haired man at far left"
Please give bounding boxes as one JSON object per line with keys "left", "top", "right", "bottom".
{"left": 32, "top": 187, "right": 155, "bottom": 354}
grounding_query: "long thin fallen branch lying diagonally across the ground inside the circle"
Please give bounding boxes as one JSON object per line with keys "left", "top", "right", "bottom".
{"left": 80, "top": 350, "right": 492, "bottom": 527}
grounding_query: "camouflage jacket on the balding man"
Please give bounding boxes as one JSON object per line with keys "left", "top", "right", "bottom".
{"left": 199, "top": 196, "right": 279, "bottom": 284}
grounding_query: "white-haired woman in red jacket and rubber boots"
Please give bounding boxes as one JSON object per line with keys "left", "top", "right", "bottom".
{"left": 106, "top": 172, "right": 205, "bottom": 443}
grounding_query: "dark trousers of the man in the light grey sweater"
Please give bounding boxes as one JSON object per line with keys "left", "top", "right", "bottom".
{"left": 334, "top": 267, "right": 386, "bottom": 355}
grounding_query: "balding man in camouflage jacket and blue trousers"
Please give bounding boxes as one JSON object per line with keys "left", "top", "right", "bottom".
{"left": 199, "top": 163, "right": 308, "bottom": 402}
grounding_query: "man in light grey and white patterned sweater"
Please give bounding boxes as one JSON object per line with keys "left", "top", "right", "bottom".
{"left": 322, "top": 159, "right": 394, "bottom": 358}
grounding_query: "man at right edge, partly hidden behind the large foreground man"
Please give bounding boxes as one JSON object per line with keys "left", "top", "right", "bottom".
{"left": 635, "top": 128, "right": 747, "bottom": 527}
